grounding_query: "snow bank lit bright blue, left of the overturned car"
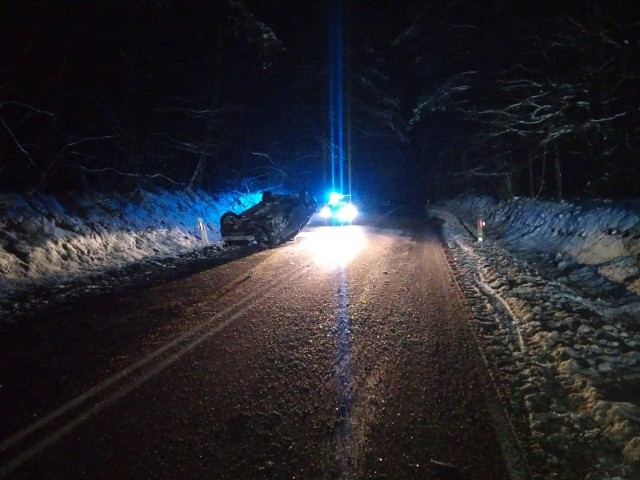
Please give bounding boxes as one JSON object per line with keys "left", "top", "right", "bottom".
{"left": 0, "top": 190, "right": 261, "bottom": 290}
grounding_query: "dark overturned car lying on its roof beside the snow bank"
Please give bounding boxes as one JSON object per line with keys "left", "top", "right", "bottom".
{"left": 220, "top": 192, "right": 318, "bottom": 247}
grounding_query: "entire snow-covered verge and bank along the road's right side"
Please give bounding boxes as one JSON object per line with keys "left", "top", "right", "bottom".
{"left": 431, "top": 198, "right": 640, "bottom": 480}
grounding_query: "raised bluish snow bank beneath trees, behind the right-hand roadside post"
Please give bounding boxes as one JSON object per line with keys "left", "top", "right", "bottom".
{"left": 447, "top": 197, "right": 640, "bottom": 294}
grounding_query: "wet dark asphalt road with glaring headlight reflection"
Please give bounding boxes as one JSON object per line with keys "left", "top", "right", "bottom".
{"left": 0, "top": 221, "right": 509, "bottom": 480}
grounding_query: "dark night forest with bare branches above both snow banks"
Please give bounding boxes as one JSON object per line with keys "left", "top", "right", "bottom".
{"left": 0, "top": 0, "right": 640, "bottom": 202}
